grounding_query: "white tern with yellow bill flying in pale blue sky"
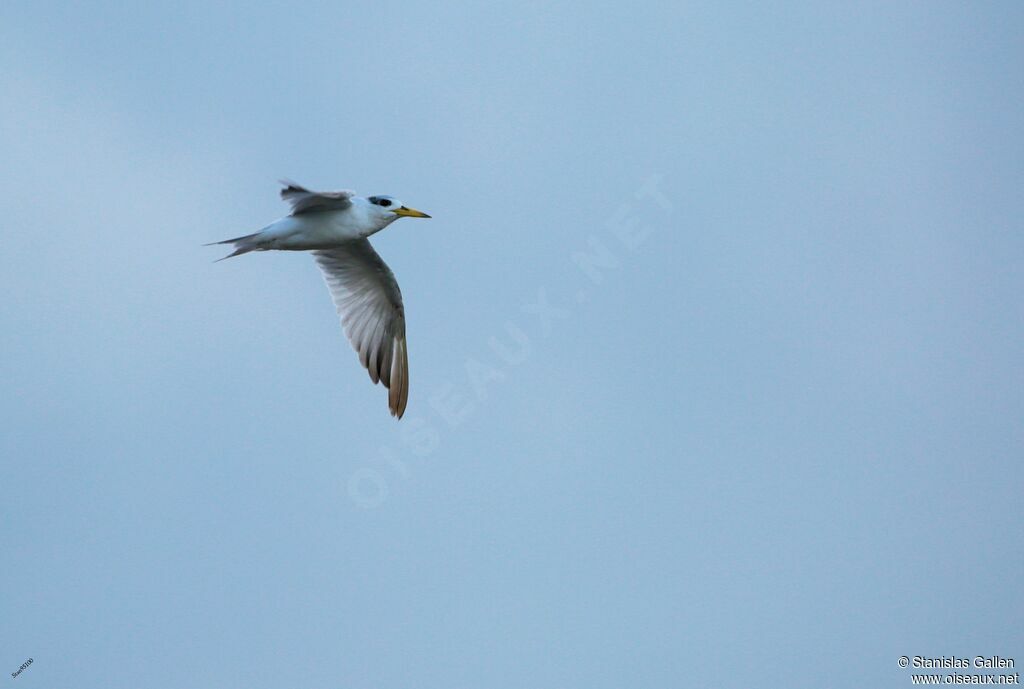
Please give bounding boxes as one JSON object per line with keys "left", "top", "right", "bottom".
{"left": 206, "top": 180, "right": 430, "bottom": 419}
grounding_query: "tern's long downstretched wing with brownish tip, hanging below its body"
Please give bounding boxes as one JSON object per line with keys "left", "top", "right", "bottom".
{"left": 313, "top": 240, "right": 409, "bottom": 419}
